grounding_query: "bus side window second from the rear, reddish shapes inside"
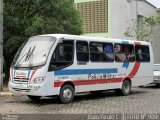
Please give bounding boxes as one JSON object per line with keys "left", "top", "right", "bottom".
{"left": 114, "top": 43, "right": 135, "bottom": 62}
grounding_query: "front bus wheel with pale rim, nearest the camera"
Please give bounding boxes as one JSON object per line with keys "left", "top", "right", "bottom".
{"left": 59, "top": 85, "right": 74, "bottom": 103}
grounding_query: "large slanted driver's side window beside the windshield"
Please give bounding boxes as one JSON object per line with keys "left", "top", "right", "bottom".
{"left": 49, "top": 41, "right": 74, "bottom": 71}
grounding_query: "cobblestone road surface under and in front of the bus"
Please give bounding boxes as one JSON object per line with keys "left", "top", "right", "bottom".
{"left": 0, "top": 86, "right": 160, "bottom": 119}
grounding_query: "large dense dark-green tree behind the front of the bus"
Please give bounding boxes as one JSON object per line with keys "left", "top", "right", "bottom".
{"left": 4, "top": 0, "right": 82, "bottom": 80}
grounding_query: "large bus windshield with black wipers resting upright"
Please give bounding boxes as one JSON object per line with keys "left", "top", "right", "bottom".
{"left": 13, "top": 36, "right": 55, "bottom": 67}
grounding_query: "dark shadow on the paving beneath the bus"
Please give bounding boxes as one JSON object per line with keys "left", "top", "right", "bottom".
{"left": 17, "top": 90, "right": 147, "bottom": 105}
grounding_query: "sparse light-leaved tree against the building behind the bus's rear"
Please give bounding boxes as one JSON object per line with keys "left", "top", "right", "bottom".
{"left": 124, "top": 16, "right": 160, "bottom": 41}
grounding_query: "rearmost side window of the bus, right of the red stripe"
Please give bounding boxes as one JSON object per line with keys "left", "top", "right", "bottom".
{"left": 135, "top": 45, "right": 150, "bottom": 62}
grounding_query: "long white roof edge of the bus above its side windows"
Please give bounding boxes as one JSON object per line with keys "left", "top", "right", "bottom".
{"left": 38, "top": 34, "right": 151, "bottom": 45}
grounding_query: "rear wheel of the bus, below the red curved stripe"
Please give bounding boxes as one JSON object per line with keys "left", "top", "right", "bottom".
{"left": 121, "top": 80, "right": 131, "bottom": 96}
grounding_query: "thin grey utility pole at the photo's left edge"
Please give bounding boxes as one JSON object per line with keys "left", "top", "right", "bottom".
{"left": 0, "top": 0, "right": 3, "bottom": 91}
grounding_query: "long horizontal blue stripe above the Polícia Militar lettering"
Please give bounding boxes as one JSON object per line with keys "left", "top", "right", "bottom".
{"left": 54, "top": 68, "right": 117, "bottom": 75}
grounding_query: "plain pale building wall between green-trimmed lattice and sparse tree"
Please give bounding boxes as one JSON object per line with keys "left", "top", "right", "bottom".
{"left": 109, "top": 0, "right": 136, "bottom": 38}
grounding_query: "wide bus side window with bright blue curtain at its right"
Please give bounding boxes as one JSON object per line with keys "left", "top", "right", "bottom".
{"left": 90, "top": 42, "right": 114, "bottom": 62}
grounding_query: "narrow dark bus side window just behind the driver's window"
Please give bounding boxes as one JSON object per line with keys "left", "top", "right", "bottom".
{"left": 76, "top": 41, "right": 89, "bottom": 62}
